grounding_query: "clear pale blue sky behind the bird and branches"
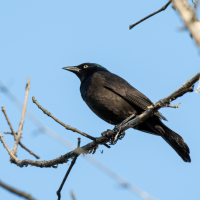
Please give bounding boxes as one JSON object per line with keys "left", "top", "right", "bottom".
{"left": 0, "top": 0, "right": 200, "bottom": 200}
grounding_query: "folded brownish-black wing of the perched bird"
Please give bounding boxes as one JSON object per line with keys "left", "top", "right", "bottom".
{"left": 103, "top": 72, "right": 167, "bottom": 121}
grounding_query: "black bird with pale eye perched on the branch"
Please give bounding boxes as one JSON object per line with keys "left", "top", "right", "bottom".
{"left": 63, "top": 63, "right": 191, "bottom": 162}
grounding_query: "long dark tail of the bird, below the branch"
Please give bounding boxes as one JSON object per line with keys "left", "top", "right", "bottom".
{"left": 144, "top": 117, "right": 191, "bottom": 162}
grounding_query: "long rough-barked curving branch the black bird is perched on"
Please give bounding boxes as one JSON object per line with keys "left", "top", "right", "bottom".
{"left": 1, "top": 72, "right": 200, "bottom": 168}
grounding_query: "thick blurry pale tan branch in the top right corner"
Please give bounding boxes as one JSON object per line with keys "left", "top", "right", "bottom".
{"left": 173, "top": 0, "right": 200, "bottom": 49}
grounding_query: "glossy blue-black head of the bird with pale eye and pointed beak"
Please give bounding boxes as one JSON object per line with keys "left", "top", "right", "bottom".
{"left": 62, "top": 63, "right": 108, "bottom": 82}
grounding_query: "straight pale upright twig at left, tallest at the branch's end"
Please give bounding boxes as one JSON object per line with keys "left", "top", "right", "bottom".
{"left": 13, "top": 78, "right": 30, "bottom": 155}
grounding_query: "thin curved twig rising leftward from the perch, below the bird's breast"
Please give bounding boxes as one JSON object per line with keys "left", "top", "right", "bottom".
{"left": 32, "top": 96, "right": 110, "bottom": 148}
